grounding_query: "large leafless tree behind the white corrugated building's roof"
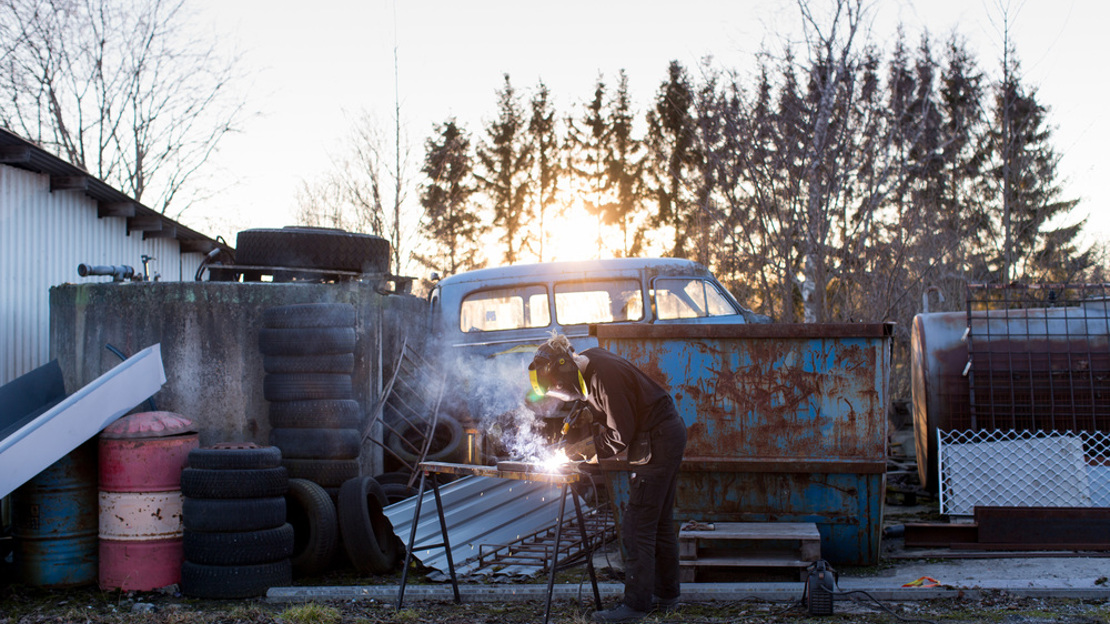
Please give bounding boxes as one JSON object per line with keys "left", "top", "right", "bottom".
{"left": 0, "top": 0, "right": 244, "bottom": 215}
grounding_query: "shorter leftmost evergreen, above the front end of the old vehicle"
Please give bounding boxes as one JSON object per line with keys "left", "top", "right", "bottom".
{"left": 420, "top": 119, "right": 485, "bottom": 275}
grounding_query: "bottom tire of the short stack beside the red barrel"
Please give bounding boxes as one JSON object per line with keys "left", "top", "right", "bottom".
{"left": 181, "top": 558, "right": 293, "bottom": 598}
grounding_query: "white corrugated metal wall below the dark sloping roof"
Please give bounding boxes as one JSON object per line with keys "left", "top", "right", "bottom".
{"left": 0, "top": 149, "right": 223, "bottom": 383}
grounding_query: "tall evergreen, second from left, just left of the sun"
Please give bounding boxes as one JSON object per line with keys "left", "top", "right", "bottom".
{"left": 475, "top": 73, "right": 534, "bottom": 264}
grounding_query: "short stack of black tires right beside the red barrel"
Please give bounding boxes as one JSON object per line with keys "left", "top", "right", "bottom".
{"left": 181, "top": 444, "right": 293, "bottom": 598}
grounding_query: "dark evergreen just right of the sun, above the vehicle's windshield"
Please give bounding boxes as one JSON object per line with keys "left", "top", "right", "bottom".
{"left": 645, "top": 61, "right": 695, "bottom": 258}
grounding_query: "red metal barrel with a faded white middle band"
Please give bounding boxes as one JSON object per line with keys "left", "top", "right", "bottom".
{"left": 99, "top": 412, "right": 199, "bottom": 591}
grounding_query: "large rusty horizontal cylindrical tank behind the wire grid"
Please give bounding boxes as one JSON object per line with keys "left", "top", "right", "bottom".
{"left": 910, "top": 300, "right": 1110, "bottom": 491}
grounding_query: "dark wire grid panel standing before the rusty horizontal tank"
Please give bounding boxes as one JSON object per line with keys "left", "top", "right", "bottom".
{"left": 963, "top": 284, "right": 1110, "bottom": 432}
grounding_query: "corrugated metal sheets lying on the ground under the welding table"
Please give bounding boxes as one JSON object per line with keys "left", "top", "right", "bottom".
{"left": 385, "top": 476, "right": 574, "bottom": 576}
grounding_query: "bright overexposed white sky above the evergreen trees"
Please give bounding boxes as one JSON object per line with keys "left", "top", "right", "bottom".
{"left": 181, "top": 0, "right": 1110, "bottom": 262}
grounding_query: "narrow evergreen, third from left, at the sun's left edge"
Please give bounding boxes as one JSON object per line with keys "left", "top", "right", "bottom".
{"left": 528, "top": 81, "right": 565, "bottom": 262}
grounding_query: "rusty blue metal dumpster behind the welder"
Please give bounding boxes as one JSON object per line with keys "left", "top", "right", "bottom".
{"left": 591, "top": 323, "right": 892, "bottom": 565}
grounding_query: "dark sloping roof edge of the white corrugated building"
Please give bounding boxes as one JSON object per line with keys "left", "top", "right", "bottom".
{"left": 0, "top": 128, "right": 231, "bottom": 253}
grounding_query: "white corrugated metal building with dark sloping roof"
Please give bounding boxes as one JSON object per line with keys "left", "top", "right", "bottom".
{"left": 0, "top": 128, "right": 224, "bottom": 384}
